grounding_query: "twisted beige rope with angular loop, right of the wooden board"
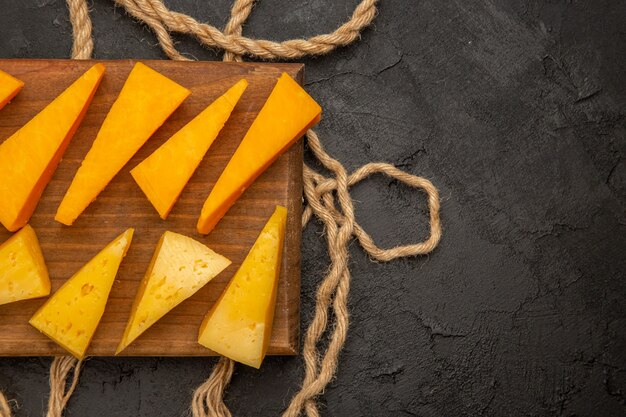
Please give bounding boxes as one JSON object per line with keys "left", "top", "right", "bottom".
{"left": 283, "top": 130, "right": 441, "bottom": 417}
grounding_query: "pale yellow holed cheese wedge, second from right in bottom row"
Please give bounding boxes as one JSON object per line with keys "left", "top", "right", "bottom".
{"left": 116, "top": 232, "right": 230, "bottom": 354}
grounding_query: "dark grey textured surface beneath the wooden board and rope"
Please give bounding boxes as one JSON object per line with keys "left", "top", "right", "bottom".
{"left": 0, "top": 0, "right": 626, "bottom": 417}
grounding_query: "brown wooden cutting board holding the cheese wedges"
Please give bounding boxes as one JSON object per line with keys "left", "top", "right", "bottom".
{"left": 0, "top": 60, "right": 304, "bottom": 356}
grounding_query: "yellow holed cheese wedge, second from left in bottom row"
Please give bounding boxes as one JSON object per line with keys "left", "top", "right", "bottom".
{"left": 29, "top": 229, "right": 133, "bottom": 359}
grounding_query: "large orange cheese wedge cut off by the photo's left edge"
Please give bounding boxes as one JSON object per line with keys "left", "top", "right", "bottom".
{"left": 0, "top": 64, "right": 104, "bottom": 231}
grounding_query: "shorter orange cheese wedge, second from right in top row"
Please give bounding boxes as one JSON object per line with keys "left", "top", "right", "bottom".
{"left": 130, "top": 80, "right": 248, "bottom": 219}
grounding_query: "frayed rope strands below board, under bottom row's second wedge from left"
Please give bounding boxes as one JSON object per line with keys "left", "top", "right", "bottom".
{"left": 46, "top": 356, "right": 82, "bottom": 417}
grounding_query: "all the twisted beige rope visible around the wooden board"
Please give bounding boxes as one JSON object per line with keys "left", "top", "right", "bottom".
{"left": 0, "top": 0, "right": 441, "bottom": 417}
